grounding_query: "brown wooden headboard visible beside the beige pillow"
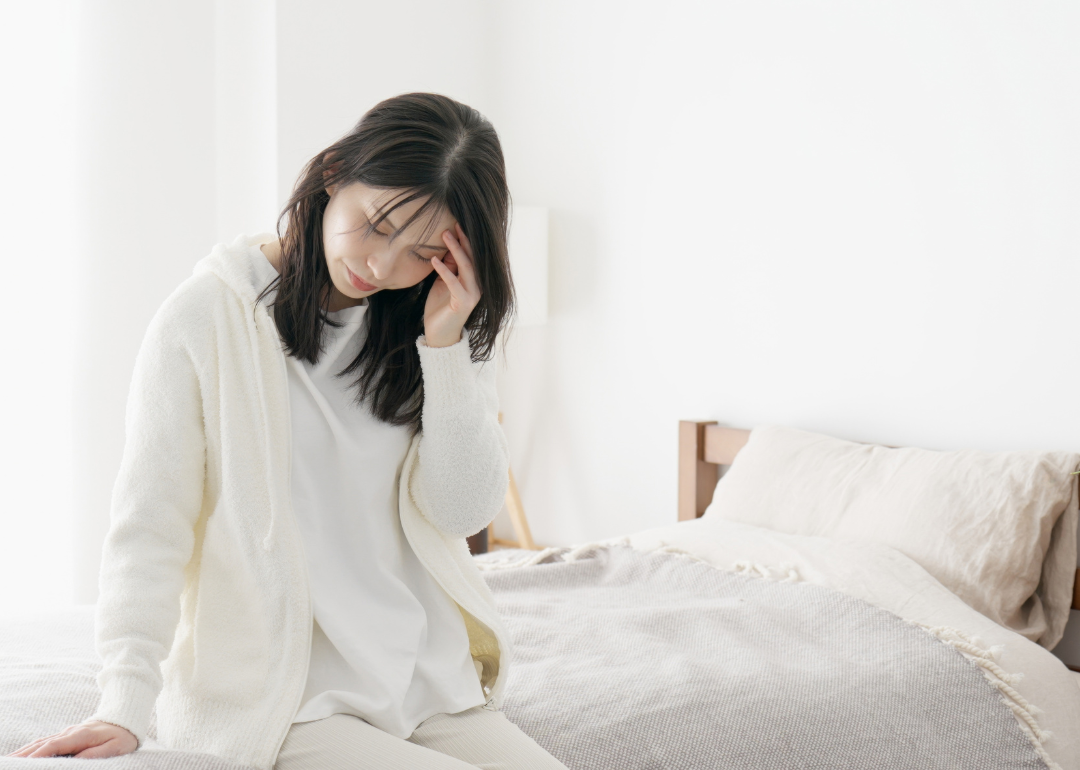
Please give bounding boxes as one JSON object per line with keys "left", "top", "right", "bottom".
{"left": 678, "top": 420, "right": 1080, "bottom": 609}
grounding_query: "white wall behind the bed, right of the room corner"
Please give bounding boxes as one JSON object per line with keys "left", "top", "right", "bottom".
{"left": 492, "top": 0, "right": 1080, "bottom": 663}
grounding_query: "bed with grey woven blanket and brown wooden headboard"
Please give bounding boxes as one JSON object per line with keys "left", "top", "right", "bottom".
{"left": 0, "top": 421, "right": 1080, "bottom": 770}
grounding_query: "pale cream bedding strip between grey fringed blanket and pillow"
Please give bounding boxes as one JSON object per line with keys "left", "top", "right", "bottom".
{"left": 604, "top": 518, "right": 1080, "bottom": 770}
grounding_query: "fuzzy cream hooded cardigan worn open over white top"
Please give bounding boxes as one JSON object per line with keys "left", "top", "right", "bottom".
{"left": 90, "top": 234, "right": 512, "bottom": 770}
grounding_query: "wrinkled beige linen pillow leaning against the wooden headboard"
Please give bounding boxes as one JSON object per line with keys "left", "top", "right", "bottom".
{"left": 703, "top": 427, "right": 1080, "bottom": 649}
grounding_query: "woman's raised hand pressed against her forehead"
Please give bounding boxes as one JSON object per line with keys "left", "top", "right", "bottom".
{"left": 423, "top": 222, "right": 481, "bottom": 348}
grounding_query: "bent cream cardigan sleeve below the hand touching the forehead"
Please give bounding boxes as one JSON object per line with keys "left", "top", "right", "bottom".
{"left": 409, "top": 334, "right": 510, "bottom": 537}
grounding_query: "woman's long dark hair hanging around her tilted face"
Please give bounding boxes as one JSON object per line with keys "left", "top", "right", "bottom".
{"left": 257, "top": 93, "right": 514, "bottom": 431}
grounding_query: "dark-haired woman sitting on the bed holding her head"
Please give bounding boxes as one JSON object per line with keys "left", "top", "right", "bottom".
{"left": 10, "top": 94, "right": 565, "bottom": 770}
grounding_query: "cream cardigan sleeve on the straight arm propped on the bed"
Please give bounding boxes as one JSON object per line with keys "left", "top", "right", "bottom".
{"left": 89, "top": 311, "right": 205, "bottom": 745}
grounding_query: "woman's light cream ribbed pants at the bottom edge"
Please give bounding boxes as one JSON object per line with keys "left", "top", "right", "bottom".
{"left": 274, "top": 706, "right": 567, "bottom": 770}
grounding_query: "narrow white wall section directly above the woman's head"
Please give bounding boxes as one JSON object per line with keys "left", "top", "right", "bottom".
{"left": 278, "top": 0, "right": 496, "bottom": 210}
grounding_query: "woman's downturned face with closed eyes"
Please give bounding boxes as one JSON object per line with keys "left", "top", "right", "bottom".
{"left": 323, "top": 181, "right": 456, "bottom": 305}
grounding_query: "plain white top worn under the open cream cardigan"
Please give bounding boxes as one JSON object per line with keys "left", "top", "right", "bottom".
{"left": 248, "top": 250, "right": 486, "bottom": 738}
